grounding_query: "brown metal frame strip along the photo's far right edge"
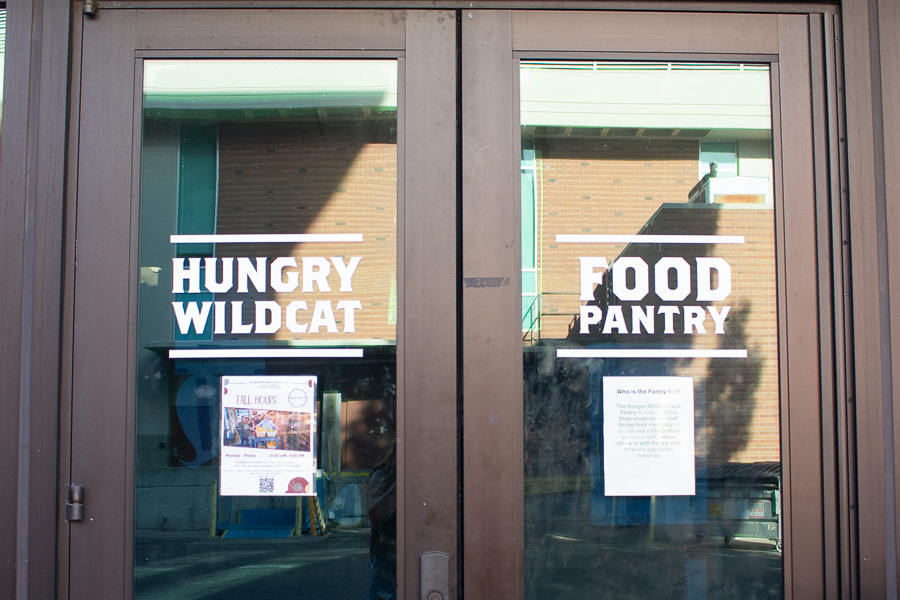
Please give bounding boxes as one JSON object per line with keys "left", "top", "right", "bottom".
{"left": 834, "top": 0, "right": 900, "bottom": 598}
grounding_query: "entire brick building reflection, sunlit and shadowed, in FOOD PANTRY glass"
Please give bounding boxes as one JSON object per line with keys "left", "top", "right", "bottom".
{"left": 536, "top": 140, "right": 780, "bottom": 463}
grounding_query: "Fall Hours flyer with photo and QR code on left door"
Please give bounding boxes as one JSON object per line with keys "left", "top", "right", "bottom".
{"left": 220, "top": 375, "right": 316, "bottom": 496}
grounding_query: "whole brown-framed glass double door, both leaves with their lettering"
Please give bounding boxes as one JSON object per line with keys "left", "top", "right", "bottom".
{"left": 67, "top": 8, "right": 835, "bottom": 599}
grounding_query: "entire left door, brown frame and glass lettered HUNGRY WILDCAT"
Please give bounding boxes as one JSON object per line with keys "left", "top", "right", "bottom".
{"left": 69, "top": 7, "right": 458, "bottom": 598}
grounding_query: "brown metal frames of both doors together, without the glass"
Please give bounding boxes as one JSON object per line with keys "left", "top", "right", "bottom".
{"left": 60, "top": 4, "right": 851, "bottom": 597}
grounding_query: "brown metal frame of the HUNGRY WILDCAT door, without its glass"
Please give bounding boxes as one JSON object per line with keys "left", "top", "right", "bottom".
{"left": 58, "top": 8, "right": 457, "bottom": 598}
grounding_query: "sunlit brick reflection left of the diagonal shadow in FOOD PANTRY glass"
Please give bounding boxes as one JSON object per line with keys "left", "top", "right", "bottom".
{"left": 537, "top": 139, "right": 698, "bottom": 338}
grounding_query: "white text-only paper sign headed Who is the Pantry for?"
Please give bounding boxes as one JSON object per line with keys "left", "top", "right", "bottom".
{"left": 603, "top": 377, "right": 695, "bottom": 496}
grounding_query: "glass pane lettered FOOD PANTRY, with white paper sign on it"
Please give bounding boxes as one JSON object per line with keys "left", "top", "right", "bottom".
{"left": 519, "top": 60, "right": 783, "bottom": 599}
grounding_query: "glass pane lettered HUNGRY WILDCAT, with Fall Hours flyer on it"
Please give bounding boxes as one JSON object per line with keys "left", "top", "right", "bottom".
{"left": 134, "top": 59, "right": 398, "bottom": 598}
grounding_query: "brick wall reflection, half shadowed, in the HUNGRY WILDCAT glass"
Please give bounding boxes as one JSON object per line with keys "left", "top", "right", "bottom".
{"left": 216, "top": 122, "right": 397, "bottom": 342}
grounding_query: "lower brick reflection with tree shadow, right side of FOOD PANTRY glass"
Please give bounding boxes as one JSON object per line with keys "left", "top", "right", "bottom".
{"left": 611, "top": 204, "right": 780, "bottom": 463}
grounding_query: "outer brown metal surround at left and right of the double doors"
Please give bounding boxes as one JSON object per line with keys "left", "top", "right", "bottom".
{"left": 0, "top": 0, "right": 884, "bottom": 597}
